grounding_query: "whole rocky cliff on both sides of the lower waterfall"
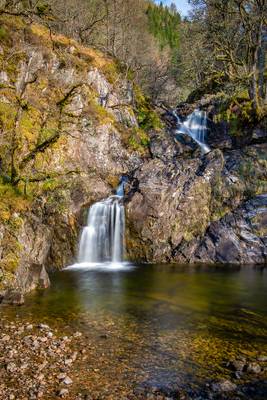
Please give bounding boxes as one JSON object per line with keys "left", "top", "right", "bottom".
{"left": 0, "top": 16, "right": 267, "bottom": 303}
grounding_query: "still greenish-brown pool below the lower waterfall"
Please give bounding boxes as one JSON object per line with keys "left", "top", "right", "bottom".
{"left": 0, "top": 265, "right": 267, "bottom": 398}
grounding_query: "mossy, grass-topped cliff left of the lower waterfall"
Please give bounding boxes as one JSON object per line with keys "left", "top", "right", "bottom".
{"left": 0, "top": 17, "right": 147, "bottom": 300}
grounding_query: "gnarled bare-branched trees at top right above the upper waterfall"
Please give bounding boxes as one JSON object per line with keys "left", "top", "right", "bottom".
{"left": 187, "top": 0, "right": 267, "bottom": 114}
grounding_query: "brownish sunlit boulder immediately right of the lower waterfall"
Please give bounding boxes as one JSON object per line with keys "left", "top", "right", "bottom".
{"left": 127, "top": 150, "right": 224, "bottom": 262}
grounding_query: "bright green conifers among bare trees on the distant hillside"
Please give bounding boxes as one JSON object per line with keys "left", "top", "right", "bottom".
{"left": 147, "top": 3, "right": 181, "bottom": 49}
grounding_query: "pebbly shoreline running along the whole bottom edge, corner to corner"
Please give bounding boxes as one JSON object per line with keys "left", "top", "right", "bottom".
{"left": 0, "top": 310, "right": 267, "bottom": 400}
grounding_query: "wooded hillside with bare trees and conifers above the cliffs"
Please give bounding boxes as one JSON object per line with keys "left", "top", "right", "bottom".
{"left": 0, "top": 0, "right": 267, "bottom": 124}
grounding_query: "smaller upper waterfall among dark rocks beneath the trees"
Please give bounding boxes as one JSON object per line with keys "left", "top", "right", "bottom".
{"left": 173, "top": 109, "right": 210, "bottom": 154}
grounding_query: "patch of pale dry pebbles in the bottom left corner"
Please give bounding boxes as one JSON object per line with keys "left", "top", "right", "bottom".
{"left": 0, "top": 318, "right": 86, "bottom": 400}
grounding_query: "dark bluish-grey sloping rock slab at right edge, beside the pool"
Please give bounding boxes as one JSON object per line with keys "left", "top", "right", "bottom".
{"left": 176, "top": 195, "right": 267, "bottom": 264}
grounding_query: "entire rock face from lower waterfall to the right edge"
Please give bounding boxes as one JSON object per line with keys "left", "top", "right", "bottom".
{"left": 127, "top": 144, "right": 267, "bottom": 264}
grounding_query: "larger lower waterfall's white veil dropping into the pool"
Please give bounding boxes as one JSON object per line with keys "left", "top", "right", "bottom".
{"left": 78, "top": 196, "right": 125, "bottom": 263}
